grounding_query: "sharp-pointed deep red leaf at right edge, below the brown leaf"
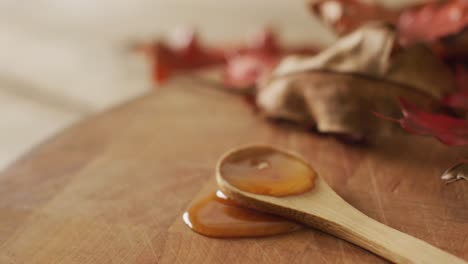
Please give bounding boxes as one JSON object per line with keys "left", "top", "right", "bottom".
{"left": 375, "top": 98, "right": 468, "bottom": 146}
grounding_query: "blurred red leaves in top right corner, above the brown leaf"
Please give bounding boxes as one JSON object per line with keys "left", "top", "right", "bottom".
{"left": 311, "top": 0, "right": 468, "bottom": 58}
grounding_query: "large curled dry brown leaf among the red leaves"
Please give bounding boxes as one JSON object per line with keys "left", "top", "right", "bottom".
{"left": 257, "top": 23, "right": 454, "bottom": 138}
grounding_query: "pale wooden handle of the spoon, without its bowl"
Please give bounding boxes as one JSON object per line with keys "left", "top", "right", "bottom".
{"left": 312, "top": 206, "right": 467, "bottom": 263}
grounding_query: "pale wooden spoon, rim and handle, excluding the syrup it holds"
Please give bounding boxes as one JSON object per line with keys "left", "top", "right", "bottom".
{"left": 216, "top": 146, "right": 467, "bottom": 264}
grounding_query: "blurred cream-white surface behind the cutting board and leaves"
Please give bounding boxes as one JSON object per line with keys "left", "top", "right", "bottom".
{"left": 0, "top": 0, "right": 420, "bottom": 168}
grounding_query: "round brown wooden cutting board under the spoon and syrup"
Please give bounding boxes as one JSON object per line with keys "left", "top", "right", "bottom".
{"left": 0, "top": 78, "right": 468, "bottom": 264}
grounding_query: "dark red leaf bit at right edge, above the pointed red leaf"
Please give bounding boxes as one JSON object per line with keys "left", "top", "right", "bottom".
{"left": 442, "top": 64, "right": 468, "bottom": 110}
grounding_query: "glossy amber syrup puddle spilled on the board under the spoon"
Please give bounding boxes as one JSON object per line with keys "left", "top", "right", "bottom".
{"left": 183, "top": 191, "right": 301, "bottom": 238}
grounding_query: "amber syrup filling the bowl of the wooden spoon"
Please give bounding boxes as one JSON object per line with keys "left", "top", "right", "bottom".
{"left": 219, "top": 146, "right": 317, "bottom": 197}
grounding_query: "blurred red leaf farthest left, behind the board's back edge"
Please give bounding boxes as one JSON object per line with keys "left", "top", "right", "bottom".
{"left": 139, "top": 29, "right": 318, "bottom": 88}
